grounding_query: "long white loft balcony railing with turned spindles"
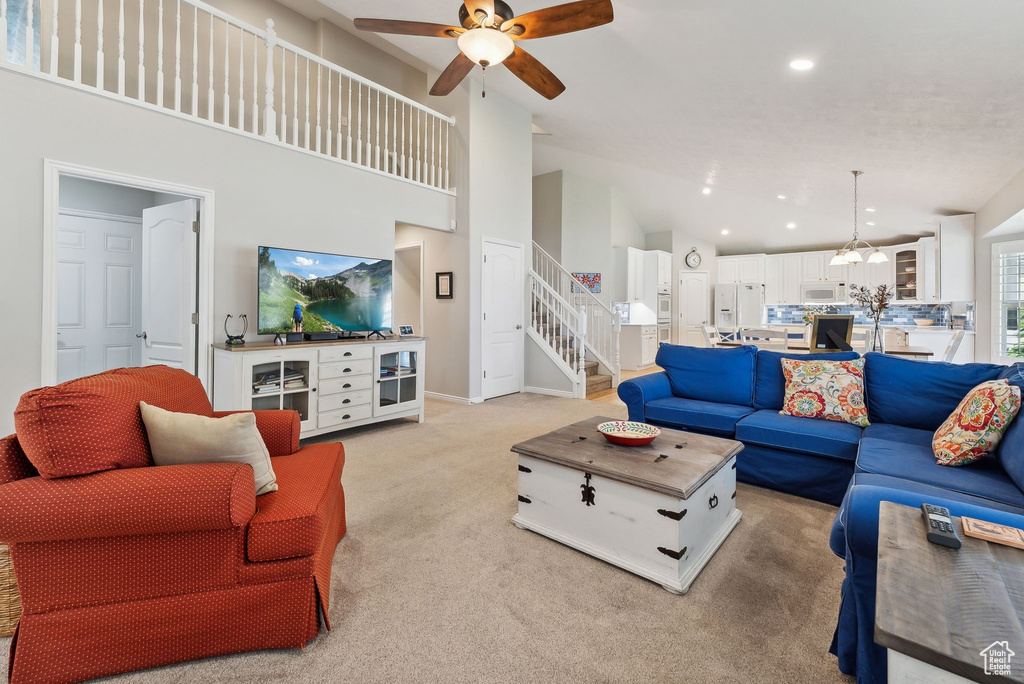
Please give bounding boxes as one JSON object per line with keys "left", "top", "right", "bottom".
{"left": 0, "top": 0, "right": 455, "bottom": 195}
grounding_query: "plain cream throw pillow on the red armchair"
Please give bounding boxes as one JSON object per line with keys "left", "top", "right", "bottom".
{"left": 138, "top": 401, "right": 278, "bottom": 497}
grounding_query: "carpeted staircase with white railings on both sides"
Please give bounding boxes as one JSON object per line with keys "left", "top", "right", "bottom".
{"left": 526, "top": 243, "right": 622, "bottom": 398}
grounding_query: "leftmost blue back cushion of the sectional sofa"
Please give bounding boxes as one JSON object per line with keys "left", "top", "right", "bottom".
{"left": 654, "top": 344, "right": 758, "bottom": 407}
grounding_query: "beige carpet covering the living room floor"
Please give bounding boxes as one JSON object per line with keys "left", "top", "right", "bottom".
{"left": 8, "top": 394, "right": 852, "bottom": 684}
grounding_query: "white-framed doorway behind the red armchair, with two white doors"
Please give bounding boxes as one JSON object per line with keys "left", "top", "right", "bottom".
{"left": 41, "top": 162, "right": 213, "bottom": 385}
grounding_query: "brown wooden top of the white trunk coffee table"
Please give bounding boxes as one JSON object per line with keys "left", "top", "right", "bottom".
{"left": 512, "top": 416, "right": 743, "bottom": 499}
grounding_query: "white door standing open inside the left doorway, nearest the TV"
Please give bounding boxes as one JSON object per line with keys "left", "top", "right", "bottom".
{"left": 141, "top": 200, "right": 197, "bottom": 373}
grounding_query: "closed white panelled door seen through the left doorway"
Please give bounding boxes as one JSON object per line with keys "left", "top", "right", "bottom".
{"left": 56, "top": 213, "right": 142, "bottom": 382}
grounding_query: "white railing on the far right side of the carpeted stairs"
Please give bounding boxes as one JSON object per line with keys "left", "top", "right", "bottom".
{"left": 532, "top": 242, "right": 623, "bottom": 387}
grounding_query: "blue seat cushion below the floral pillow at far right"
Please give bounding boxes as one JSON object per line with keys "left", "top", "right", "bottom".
{"left": 857, "top": 437, "right": 1024, "bottom": 508}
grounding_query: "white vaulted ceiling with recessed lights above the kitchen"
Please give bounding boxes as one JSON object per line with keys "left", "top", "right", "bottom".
{"left": 322, "top": 0, "right": 1024, "bottom": 253}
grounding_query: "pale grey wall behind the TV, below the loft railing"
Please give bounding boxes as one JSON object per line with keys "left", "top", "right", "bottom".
{"left": 0, "top": 70, "right": 452, "bottom": 431}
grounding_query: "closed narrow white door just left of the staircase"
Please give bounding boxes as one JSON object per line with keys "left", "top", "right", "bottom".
{"left": 481, "top": 240, "right": 524, "bottom": 399}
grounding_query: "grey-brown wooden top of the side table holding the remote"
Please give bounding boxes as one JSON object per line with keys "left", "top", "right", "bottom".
{"left": 874, "top": 501, "right": 1024, "bottom": 682}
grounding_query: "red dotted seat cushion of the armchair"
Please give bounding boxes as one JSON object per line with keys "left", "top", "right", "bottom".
{"left": 246, "top": 443, "right": 345, "bottom": 562}
